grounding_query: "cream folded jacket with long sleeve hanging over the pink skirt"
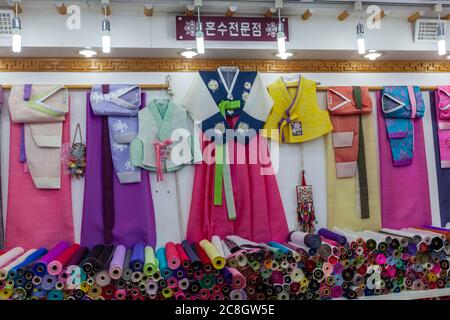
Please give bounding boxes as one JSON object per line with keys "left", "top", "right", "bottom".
{"left": 9, "top": 85, "right": 69, "bottom": 189}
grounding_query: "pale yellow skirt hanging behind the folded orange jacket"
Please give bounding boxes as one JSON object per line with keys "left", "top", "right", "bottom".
{"left": 326, "top": 114, "right": 381, "bottom": 231}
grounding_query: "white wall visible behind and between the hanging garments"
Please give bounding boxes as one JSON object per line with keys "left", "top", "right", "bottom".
{"left": 0, "top": 73, "right": 450, "bottom": 245}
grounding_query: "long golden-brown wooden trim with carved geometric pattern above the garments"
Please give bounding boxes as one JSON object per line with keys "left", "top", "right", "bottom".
{"left": 0, "top": 58, "right": 450, "bottom": 73}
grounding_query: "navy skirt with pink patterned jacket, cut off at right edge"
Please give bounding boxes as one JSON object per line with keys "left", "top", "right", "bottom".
{"left": 430, "top": 92, "right": 450, "bottom": 226}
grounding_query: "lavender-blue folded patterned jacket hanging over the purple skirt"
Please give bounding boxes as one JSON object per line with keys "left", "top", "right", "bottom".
{"left": 91, "top": 85, "right": 141, "bottom": 183}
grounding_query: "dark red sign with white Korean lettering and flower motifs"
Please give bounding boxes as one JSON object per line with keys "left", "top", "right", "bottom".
{"left": 176, "top": 16, "right": 289, "bottom": 41}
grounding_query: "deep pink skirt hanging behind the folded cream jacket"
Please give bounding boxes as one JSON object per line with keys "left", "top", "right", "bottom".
{"left": 6, "top": 114, "right": 74, "bottom": 250}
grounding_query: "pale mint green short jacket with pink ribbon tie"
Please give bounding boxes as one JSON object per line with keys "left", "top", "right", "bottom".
{"left": 130, "top": 99, "right": 201, "bottom": 181}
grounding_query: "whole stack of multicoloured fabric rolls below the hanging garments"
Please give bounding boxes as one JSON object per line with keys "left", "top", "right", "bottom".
{"left": 0, "top": 226, "right": 450, "bottom": 300}
